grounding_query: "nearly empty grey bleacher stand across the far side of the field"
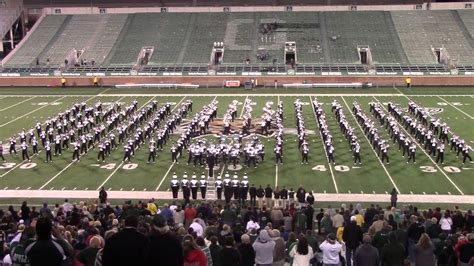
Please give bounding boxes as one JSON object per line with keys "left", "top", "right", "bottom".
{"left": 4, "top": 10, "right": 474, "bottom": 71}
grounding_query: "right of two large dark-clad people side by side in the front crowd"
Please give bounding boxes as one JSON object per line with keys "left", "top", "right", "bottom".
{"left": 147, "top": 214, "right": 183, "bottom": 266}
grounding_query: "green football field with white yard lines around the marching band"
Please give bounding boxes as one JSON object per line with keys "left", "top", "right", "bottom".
{"left": 0, "top": 88, "right": 474, "bottom": 198}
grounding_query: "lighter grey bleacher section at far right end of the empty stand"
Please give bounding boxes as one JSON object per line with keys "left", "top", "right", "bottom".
{"left": 391, "top": 11, "right": 474, "bottom": 64}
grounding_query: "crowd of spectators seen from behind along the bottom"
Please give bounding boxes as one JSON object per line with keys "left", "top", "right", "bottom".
{"left": 0, "top": 196, "right": 474, "bottom": 266}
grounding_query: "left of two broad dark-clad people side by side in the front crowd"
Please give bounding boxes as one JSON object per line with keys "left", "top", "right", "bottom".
{"left": 102, "top": 215, "right": 148, "bottom": 266}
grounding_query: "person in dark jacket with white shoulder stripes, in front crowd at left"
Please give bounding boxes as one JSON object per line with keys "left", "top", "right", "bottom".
{"left": 25, "top": 218, "right": 72, "bottom": 266}
